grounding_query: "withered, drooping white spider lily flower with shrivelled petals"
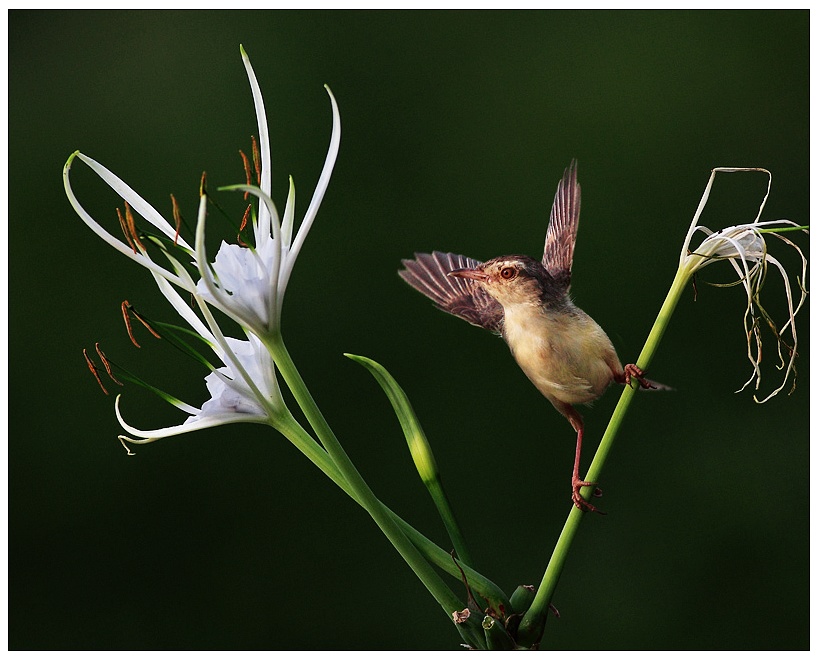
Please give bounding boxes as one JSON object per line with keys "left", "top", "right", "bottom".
{"left": 679, "top": 167, "right": 807, "bottom": 403}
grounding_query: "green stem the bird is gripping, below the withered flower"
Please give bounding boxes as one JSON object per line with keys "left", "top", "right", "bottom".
{"left": 519, "top": 267, "right": 690, "bottom": 645}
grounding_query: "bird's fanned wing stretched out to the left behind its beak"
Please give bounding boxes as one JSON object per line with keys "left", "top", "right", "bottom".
{"left": 398, "top": 252, "right": 503, "bottom": 334}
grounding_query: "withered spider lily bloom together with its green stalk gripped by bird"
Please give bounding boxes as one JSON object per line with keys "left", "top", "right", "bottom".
{"left": 520, "top": 167, "right": 807, "bottom": 644}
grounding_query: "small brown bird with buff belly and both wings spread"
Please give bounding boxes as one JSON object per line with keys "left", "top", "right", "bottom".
{"left": 398, "top": 160, "right": 656, "bottom": 511}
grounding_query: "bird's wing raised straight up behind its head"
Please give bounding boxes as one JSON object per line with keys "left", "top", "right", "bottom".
{"left": 542, "top": 159, "right": 580, "bottom": 291}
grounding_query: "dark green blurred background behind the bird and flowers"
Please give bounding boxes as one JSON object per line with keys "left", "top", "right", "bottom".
{"left": 8, "top": 11, "right": 809, "bottom": 649}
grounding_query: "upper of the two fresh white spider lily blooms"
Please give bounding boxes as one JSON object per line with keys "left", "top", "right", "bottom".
{"left": 63, "top": 48, "right": 341, "bottom": 337}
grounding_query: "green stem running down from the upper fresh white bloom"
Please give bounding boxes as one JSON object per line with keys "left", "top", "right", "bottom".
{"left": 265, "top": 335, "right": 463, "bottom": 615}
